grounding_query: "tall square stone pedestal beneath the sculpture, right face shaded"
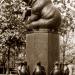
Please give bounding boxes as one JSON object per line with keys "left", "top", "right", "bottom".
{"left": 26, "top": 29, "right": 59, "bottom": 75}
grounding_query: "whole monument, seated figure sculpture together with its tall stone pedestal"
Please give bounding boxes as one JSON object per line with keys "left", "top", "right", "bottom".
{"left": 24, "top": 0, "right": 61, "bottom": 75}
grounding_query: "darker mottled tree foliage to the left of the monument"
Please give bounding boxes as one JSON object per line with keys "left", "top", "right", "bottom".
{"left": 0, "top": 0, "right": 25, "bottom": 67}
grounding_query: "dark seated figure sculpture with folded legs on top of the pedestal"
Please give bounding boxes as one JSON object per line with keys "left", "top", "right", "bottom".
{"left": 24, "top": 0, "right": 61, "bottom": 29}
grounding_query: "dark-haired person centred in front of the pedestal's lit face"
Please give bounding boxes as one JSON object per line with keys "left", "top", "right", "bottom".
{"left": 33, "top": 62, "right": 46, "bottom": 75}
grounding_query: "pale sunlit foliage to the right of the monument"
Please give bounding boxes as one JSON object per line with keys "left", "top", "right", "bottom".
{"left": 54, "top": 1, "right": 75, "bottom": 61}
